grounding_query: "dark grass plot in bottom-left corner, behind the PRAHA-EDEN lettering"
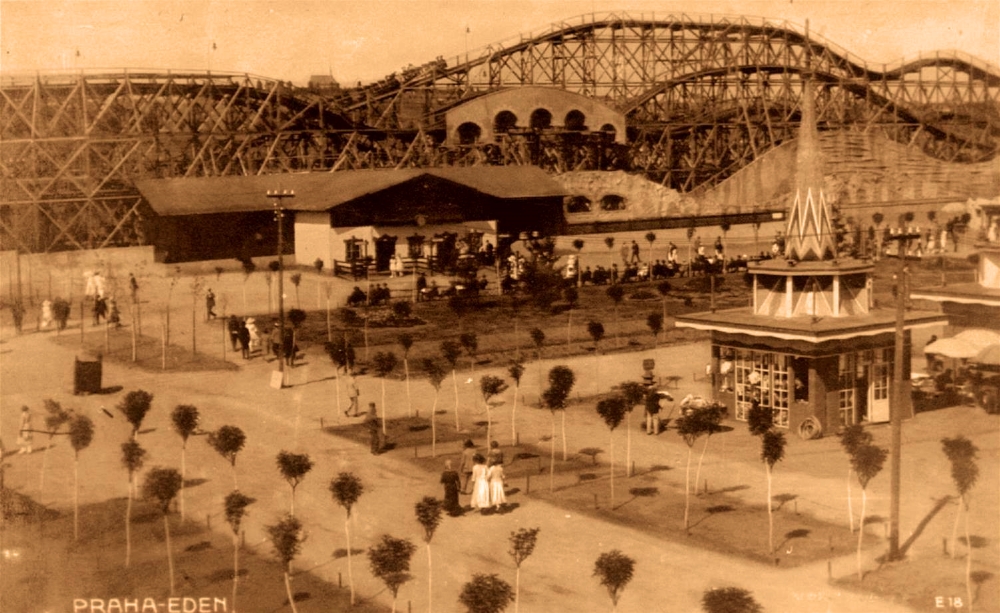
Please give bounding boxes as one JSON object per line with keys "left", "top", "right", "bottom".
{"left": 0, "top": 489, "right": 387, "bottom": 613}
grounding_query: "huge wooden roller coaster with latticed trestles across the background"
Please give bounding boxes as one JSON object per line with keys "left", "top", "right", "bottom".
{"left": 0, "top": 14, "right": 1000, "bottom": 251}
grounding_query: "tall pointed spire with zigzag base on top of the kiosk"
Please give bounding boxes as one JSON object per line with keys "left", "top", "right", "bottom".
{"left": 785, "top": 72, "right": 837, "bottom": 261}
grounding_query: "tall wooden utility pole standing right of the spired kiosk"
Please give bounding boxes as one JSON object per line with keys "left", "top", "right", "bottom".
{"left": 888, "top": 228, "right": 920, "bottom": 560}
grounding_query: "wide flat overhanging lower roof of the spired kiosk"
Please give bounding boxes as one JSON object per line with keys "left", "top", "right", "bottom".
{"left": 677, "top": 307, "right": 948, "bottom": 343}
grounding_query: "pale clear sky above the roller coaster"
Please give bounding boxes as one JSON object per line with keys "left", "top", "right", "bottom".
{"left": 0, "top": 0, "right": 1000, "bottom": 85}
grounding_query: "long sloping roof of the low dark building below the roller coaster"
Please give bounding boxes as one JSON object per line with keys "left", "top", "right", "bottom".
{"left": 136, "top": 166, "right": 566, "bottom": 215}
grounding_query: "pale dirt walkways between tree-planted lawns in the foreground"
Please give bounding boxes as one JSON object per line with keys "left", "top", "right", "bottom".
{"left": 0, "top": 298, "right": 1000, "bottom": 613}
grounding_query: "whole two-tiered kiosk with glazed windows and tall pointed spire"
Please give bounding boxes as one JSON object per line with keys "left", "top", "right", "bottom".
{"left": 676, "top": 81, "right": 945, "bottom": 438}
